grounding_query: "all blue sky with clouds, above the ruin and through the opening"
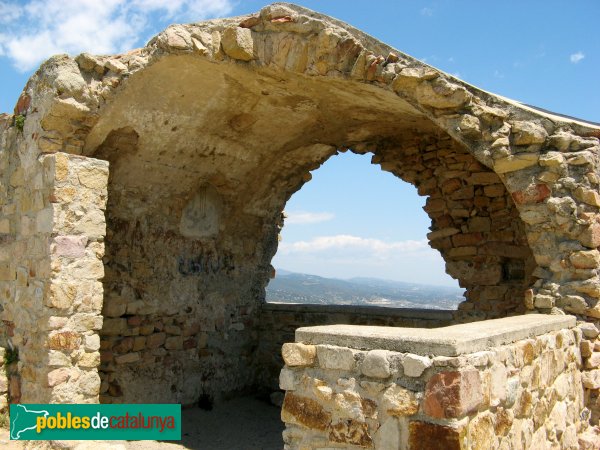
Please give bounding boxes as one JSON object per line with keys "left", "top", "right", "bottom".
{"left": 0, "top": 0, "right": 600, "bottom": 286}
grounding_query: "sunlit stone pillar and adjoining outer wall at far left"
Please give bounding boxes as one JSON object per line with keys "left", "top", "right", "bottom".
{"left": 0, "top": 98, "right": 108, "bottom": 403}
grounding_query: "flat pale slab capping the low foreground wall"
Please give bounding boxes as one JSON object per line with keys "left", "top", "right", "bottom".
{"left": 296, "top": 314, "right": 576, "bottom": 356}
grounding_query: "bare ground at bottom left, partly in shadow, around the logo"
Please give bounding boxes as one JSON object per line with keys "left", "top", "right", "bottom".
{"left": 0, "top": 397, "right": 283, "bottom": 450}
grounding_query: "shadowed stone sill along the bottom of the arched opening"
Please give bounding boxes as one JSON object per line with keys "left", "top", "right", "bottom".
{"left": 262, "top": 302, "right": 456, "bottom": 322}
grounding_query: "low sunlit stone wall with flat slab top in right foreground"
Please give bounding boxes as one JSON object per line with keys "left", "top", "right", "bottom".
{"left": 280, "top": 315, "right": 600, "bottom": 450}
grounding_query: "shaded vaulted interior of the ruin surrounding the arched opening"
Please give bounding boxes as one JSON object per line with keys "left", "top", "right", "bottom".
{"left": 88, "top": 55, "right": 532, "bottom": 404}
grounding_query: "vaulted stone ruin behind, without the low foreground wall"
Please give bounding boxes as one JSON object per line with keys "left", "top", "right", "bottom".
{"left": 0, "top": 3, "right": 600, "bottom": 442}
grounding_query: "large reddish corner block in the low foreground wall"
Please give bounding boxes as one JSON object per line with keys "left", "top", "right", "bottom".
{"left": 423, "top": 369, "right": 483, "bottom": 419}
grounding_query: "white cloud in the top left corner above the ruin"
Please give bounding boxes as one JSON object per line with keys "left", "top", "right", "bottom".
{"left": 0, "top": 0, "right": 233, "bottom": 72}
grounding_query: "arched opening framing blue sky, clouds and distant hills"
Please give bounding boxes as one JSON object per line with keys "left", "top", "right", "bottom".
{"left": 266, "top": 151, "right": 464, "bottom": 309}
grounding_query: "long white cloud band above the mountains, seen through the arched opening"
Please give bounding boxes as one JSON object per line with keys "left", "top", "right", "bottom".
{"left": 279, "top": 234, "right": 430, "bottom": 256}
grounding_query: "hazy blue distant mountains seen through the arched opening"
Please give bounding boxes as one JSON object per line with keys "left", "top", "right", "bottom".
{"left": 267, "top": 269, "right": 464, "bottom": 309}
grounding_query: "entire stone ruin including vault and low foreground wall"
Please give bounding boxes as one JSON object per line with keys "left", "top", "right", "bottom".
{"left": 0, "top": 0, "right": 600, "bottom": 449}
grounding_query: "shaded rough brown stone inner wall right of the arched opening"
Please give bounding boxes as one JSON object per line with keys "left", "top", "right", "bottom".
{"left": 373, "top": 134, "right": 535, "bottom": 321}
